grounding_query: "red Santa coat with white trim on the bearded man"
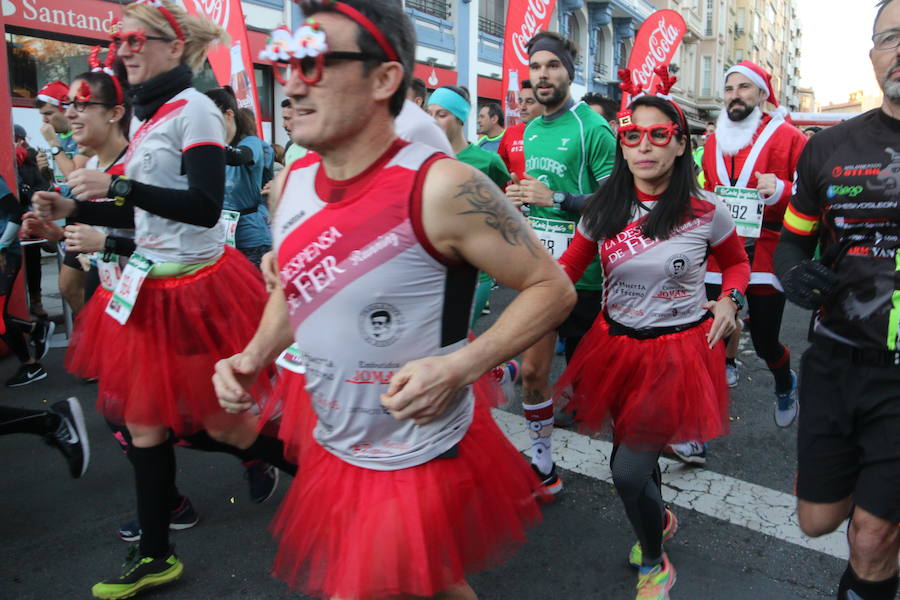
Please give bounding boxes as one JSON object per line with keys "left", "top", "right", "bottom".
{"left": 703, "top": 114, "right": 807, "bottom": 289}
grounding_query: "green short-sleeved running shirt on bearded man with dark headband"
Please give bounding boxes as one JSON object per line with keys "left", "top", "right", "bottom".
{"left": 524, "top": 102, "right": 616, "bottom": 290}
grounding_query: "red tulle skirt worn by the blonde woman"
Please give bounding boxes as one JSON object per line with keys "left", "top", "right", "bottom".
{"left": 66, "top": 246, "right": 267, "bottom": 436}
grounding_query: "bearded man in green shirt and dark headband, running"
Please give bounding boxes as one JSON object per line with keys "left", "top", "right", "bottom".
{"left": 507, "top": 31, "right": 616, "bottom": 494}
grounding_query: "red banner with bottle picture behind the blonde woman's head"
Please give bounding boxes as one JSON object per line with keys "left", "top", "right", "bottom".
{"left": 184, "top": 0, "right": 263, "bottom": 138}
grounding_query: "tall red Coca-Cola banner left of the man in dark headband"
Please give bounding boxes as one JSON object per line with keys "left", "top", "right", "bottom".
{"left": 502, "top": 0, "right": 556, "bottom": 125}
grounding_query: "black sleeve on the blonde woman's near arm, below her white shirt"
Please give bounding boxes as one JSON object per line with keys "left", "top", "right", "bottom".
{"left": 126, "top": 145, "right": 225, "bottom": 227}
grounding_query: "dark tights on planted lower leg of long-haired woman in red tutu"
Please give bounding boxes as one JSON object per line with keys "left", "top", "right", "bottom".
{"left": 610, "top": 445, "right": 665, "bottom": 566}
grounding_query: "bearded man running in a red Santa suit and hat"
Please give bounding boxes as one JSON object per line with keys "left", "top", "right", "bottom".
{"left": 703, "top": 61, "right": 806, "bottom": 427}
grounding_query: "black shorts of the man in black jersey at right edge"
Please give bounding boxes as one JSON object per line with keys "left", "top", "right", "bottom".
{"left": 797, "top": 336, "right": 900, "bottom": 524}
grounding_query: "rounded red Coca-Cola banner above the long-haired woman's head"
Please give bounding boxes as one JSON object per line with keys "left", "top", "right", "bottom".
{"left": 622, "top": 10, "right": 687, "bottom": 109}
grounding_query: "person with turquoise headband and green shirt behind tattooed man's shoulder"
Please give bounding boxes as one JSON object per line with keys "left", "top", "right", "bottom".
{"left": 427, "top": 86, "right": 509, "bottom": 327}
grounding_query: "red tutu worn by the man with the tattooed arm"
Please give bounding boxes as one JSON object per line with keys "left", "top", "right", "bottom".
{"left": 272, "top": 398, "right": 543, "bottom": 600}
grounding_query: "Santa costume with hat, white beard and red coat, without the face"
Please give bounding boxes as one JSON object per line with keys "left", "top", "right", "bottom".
{"left": 703, "top": 60, "right": 806, "bottom": 290}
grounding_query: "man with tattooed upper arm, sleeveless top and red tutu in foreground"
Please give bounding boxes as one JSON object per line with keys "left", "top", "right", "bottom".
{"left": 214, "top": 0, "right": 575, "bottom": 600}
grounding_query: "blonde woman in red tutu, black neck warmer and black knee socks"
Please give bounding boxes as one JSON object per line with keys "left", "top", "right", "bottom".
{"left": 35, "top": 0, "right": 291, "bottom": 598}
